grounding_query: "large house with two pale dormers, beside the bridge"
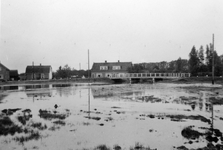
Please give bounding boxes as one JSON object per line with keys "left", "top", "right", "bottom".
{"left": 91, "top": 61, "right": 132, "bottom": 78}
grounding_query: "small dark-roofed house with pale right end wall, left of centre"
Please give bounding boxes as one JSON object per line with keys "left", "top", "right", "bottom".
{"left": 26, "top": 64, "right": 53, "bottom": 80}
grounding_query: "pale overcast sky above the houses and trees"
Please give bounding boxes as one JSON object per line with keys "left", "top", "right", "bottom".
{"left": 0, "top": 0, "right": 223, "bottom": 73}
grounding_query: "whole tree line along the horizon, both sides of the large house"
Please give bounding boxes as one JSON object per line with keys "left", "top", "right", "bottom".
{"left": 53, "top": 44, "right": 223, "bottom": 79}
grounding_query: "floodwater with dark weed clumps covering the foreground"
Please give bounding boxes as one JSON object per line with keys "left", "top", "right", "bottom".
{"left": 0, "top": 83, "right": 223, "bottom": 150}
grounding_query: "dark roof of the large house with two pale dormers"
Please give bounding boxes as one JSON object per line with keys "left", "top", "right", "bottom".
{"left": 91, "top": 62, "right": 132, "bottom": 72}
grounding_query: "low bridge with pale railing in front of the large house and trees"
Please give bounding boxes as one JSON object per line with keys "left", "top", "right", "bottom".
{"left": 109, "top": 73, "right": 190, "bottom": 83}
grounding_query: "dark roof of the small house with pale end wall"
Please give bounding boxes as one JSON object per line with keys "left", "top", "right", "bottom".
{"left": 26, "top": 66, "right": 51, "bottom": 73}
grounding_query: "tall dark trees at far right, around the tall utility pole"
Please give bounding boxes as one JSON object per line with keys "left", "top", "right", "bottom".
{"left": 188, "top": 44, "right": 223, "bottom": 76}
